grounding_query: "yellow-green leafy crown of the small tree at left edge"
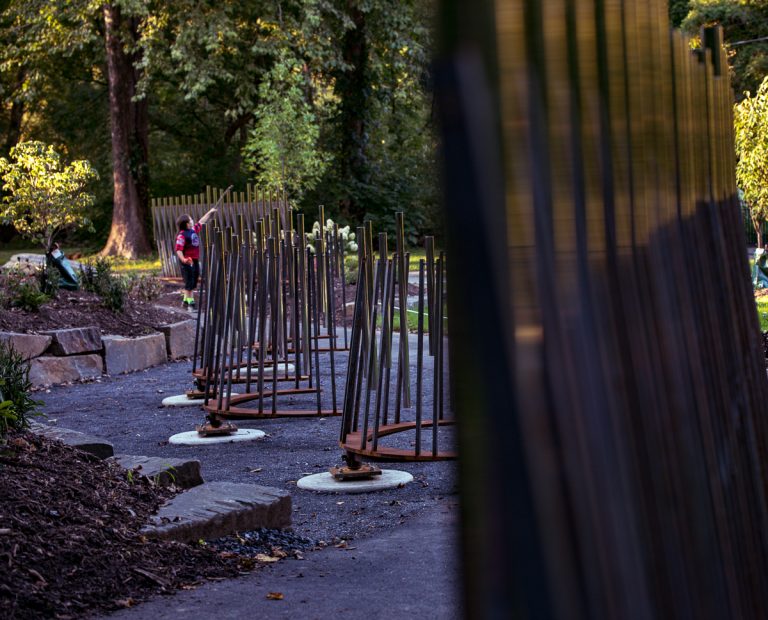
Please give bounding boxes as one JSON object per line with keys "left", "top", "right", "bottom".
{"left": 0, "top": 142, "right": 98, "bottom": 251}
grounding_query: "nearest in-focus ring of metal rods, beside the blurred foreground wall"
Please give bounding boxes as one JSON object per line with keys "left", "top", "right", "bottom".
{"left": 340, "top": 213, "right": 455, "bottom": 462}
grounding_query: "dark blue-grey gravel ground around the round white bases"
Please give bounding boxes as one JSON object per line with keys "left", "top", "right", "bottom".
{"left": 37, "top": 344, "right": 458, "bottom": 543}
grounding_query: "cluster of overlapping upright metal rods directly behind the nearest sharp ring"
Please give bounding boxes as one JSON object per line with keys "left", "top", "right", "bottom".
{"left": 192, "top": 208, "right": 349, "bottom": 418}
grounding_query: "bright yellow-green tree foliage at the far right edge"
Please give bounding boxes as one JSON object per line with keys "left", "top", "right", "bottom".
{"left": 734, "top": 78, "right": 768, "bottom": 245}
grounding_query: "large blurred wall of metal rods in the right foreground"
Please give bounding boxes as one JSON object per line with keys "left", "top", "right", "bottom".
{"left": 437, "top": 0, "right": 768, "bottom": 619}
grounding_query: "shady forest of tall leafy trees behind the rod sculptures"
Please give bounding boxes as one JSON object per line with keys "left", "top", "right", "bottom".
{"left": 0, "top": 0, "right": 437, "bottom": 257}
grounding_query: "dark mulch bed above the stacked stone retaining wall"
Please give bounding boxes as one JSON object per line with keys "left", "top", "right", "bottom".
{"left": 0, "top": 290, "right": 184, "bottom": 336}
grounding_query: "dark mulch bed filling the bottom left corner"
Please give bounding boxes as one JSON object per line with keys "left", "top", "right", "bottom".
{"left": 0, "top": 433, "right": 239, "bottom": 618}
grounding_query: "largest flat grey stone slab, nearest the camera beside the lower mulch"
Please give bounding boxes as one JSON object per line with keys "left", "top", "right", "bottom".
{"left": 142, "top": 482, "right": 291, "bottom": 542}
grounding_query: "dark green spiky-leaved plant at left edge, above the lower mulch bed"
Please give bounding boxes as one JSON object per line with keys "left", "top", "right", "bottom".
{"left": 0, "top": 341, "right": 41, "bottom": 436}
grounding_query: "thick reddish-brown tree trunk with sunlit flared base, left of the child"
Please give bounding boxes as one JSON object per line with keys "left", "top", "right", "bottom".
{"left": 101, "top": 3, "right": 151, "bottom": 258}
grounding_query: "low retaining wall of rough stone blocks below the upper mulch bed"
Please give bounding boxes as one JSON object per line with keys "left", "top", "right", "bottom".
{"left": 0, "top": 319, "right": 195, "bottom": 387}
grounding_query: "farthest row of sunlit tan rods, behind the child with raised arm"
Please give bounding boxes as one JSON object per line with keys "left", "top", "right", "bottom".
{"left": 151, "top": 183, "right": 290, "bottom": 278}
